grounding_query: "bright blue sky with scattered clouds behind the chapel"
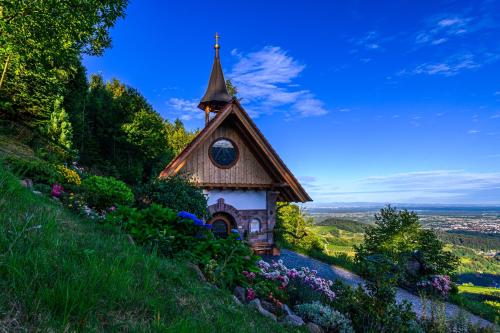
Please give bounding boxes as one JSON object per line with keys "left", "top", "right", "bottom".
{"left": 84, "top": 0, "right": 500, "bottom": 204}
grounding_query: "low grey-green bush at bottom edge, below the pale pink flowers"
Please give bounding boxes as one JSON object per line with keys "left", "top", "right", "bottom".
{"left": 295, "top": 302, "right": 354, "bottom": 333}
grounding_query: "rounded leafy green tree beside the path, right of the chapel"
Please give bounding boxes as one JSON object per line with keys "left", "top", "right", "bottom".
{"left": 355, "top": 206, "right": 458, "bottom": 285}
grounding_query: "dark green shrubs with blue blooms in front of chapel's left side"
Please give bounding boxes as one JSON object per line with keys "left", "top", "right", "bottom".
{"left": 106, "top": 204, "right": 257, "bottom": 288}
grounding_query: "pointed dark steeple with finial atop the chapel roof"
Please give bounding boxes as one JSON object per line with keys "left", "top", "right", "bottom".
{"left": 198, "top": 33, "right": 233, "bottom": 124}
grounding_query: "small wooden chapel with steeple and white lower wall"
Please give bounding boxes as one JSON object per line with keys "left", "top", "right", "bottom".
{"left": 160, "top": 34, "right": 311, "bottom": 253}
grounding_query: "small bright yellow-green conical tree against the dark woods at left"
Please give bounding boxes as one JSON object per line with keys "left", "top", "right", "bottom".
{"left": 47, "top": 97, "right": 73, "bottom": 149}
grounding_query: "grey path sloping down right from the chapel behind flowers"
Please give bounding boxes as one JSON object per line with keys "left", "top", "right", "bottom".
{"left": 265, "top": 249, "right": 498, "bottom": 329}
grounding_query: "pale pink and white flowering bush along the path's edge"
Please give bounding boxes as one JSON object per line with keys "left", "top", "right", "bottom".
{"left": 258, "top": 260, "right": 335, "bottom": 301}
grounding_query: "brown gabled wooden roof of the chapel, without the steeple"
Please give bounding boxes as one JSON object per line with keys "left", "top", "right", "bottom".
{"left": 160, "top": 100, "right": 312, "bottom": 202}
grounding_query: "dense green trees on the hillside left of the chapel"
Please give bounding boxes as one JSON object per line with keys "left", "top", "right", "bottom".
{"left": 0, "top": 0, "right": 195, "bottom": 185}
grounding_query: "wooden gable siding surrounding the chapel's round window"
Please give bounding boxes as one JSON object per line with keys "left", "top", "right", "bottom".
{"left": 182, "top": 124, "right": 273, "bottom": 185}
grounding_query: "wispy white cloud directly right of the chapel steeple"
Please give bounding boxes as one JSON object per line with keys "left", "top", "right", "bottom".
{"left": 228, "top": 46, "right": 328, "bottom": 117}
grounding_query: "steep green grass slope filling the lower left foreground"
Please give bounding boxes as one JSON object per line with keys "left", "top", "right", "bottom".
{"left": 0, "top": 168, "right": 300, "bottom": 332}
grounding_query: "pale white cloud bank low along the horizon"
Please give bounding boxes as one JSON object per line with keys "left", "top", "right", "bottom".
{"left": 310, "top": 170, "right": 500, "bottom": 203}
